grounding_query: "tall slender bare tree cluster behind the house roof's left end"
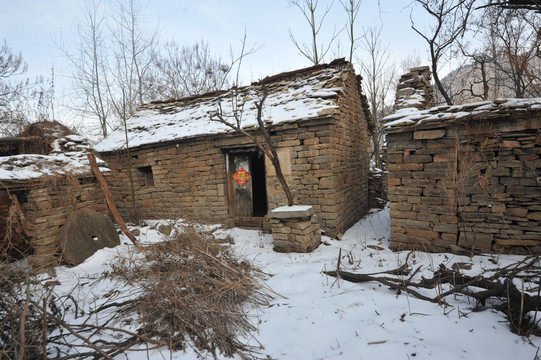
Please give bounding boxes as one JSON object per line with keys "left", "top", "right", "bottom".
{"left": 57, "top": 0, "right": 157, "bottom": 137}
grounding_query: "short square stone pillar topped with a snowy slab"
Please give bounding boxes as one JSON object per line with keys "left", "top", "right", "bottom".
{"left": 270, "top": 205, "right": 321, "bottom": 252}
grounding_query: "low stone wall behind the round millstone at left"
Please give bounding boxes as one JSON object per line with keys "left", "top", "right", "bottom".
{"left": 16, "top": 177, "right": 109, "bottom": 267}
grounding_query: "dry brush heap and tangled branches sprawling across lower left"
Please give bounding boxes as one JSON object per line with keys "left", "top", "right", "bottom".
{"left": 0, "top": 226, "right": 272, "bottom": 359}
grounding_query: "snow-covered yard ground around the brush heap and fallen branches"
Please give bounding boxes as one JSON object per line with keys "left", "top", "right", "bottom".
{"left": 44, "top": 211, "right": 541, "bottom": 360}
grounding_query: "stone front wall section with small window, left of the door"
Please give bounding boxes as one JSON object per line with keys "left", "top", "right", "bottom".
{"left": 103, "top": 138, "right": 227, "bottom": 222}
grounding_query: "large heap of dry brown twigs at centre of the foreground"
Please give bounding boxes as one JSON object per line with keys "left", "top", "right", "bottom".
{"left": 109, "top": 226, "right": 272, "bottom": 356}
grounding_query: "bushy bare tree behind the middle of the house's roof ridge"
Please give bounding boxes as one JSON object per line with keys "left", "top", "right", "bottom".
{"left": 150, "top": 40, "right": 231, "bottom": 100}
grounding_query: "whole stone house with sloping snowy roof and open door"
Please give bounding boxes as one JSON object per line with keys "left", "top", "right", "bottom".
{"left": 95, "top": 60, "right": 370, "bottom": 236}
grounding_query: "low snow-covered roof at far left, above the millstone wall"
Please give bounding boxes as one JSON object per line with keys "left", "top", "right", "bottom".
{"left": 0, "top": 135, "right": 109, "bottom": 184}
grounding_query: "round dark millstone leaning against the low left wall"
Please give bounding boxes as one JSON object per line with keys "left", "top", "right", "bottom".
{"left": 59, "top": 209, "right": 120, "bottom": 265}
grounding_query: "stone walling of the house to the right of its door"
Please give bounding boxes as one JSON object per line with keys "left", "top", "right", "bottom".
{"left": 268, "top": 68, "right": 370, "bottom": 236}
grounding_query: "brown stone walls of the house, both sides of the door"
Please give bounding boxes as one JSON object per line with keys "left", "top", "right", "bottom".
{"left": 102, "top": 67, "right": 370, "bottom": 236}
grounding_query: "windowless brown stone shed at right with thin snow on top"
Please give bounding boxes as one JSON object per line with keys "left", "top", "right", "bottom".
{"left": 384, "top": 69, "right": 541, "bottom": 253}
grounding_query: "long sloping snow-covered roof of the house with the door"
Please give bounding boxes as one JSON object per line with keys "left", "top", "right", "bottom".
{"left": 95, "top": 60, "right": 352, "bottom": 152}
